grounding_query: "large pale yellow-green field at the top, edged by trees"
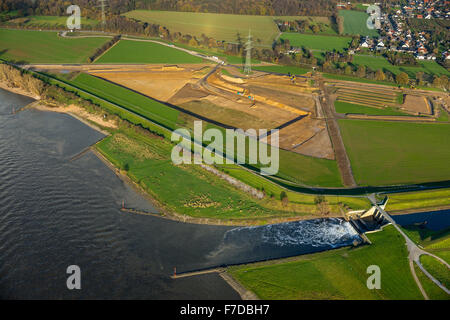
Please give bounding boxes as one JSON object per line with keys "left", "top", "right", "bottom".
{"left": 125, "top": 10, "right": 279, "bottom": 45}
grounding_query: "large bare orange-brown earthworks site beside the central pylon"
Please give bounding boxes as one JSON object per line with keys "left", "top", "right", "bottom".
{"left": 87, "top": 65, "right": 334, "bottom": 159}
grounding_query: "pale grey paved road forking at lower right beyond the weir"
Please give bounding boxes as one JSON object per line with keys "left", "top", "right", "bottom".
{"left": 368, "top": 194, "right": 450, "bottom": 300}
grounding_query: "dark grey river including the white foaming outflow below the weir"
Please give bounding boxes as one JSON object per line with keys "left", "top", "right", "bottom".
{"left": 0, "top": 89, "right": 360, "bottom": 299}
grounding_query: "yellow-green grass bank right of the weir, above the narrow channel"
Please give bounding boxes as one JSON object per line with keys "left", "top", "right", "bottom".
{"left": 386, "top": 189, "right": 450, "bottom": 211}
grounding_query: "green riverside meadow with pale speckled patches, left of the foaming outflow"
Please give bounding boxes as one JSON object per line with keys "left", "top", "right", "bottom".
{"left": 97, "top": 131, "right": 296, "bottom": 219}
